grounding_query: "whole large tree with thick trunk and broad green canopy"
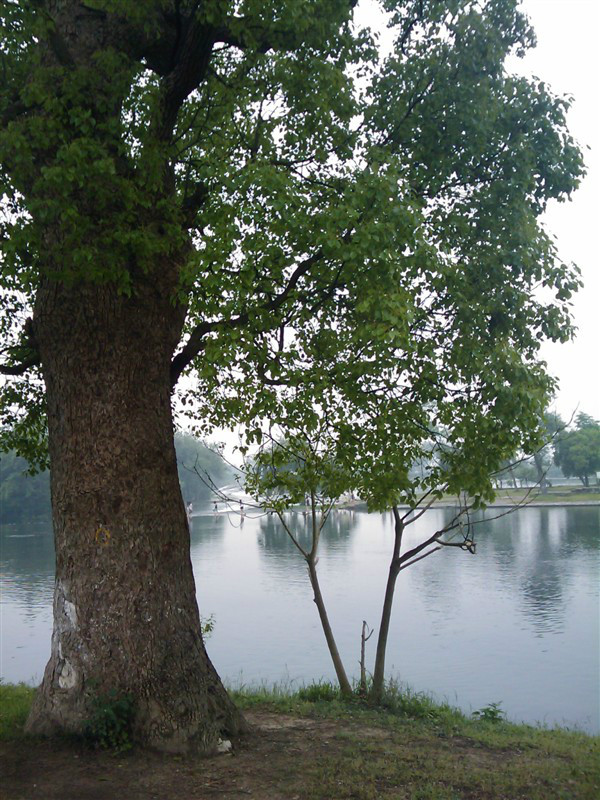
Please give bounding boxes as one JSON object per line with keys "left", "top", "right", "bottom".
{"left": 0, "top": 0, "right": 582, "bottom": 749}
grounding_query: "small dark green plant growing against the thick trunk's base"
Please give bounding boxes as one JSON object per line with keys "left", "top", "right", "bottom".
{"left": 84, "top": 689, "right": 135, "bottom": 753}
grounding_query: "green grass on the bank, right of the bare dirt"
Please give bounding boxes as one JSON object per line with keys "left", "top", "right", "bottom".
{"left": 236, "top": 683, "right": 600, "bottom": 800}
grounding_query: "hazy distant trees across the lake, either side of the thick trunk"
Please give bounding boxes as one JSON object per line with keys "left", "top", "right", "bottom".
{"left": 0, "top": 433, "right": 233, "bottom": 524}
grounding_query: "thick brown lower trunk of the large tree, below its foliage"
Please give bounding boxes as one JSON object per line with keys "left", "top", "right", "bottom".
{"left": 27, "top": 270, "right": 244, "bottom": 752}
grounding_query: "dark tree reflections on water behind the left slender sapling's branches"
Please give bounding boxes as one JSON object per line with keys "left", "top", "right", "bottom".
{"left": 258, "top": 511, "right": 357, "bottom": 574}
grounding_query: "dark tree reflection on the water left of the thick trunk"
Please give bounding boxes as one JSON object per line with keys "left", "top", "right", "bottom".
{"left": 0, "top": 522, "right": 55, "bottom": 615}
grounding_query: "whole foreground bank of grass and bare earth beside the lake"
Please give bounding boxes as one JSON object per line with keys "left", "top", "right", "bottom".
{"left": 0, "top": 685, "right": 600, "bottom": 800}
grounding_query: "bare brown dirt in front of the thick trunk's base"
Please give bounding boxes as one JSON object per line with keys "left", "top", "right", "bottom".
{"left": 0, "top": 711, "right": 507, "bottom": 800}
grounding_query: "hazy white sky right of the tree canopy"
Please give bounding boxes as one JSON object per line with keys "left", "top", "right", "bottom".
{"left": 510, "top": 0, "right": 600, "bottom": 419}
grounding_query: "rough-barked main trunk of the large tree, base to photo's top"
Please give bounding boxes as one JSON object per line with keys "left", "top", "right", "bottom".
{"left": 7, "top": 0, "right": 244, "bottom": 752}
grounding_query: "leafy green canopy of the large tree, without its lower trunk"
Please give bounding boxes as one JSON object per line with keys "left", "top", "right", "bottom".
{"left": 0, "top": 0, "right": 584, "bottom": 509}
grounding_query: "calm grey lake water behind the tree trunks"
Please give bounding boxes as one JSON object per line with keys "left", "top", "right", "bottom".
{"left": 0, "top": 507, "right": 600, "bottom": 732}
